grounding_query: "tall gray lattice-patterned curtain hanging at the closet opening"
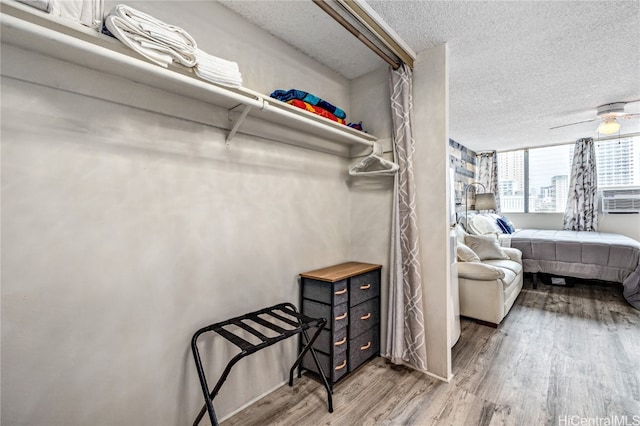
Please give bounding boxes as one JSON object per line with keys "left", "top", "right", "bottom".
{"left": 387, "top": 64, "right": 427, "bottom": 370}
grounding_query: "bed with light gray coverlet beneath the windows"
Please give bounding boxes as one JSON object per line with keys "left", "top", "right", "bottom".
{"left": 510, "top": 229, "right": 640, "bottom": 309}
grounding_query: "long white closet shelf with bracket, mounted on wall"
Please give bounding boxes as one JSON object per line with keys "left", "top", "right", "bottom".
{"left": 0, "top": 0, "right": 377, "bottom": 156}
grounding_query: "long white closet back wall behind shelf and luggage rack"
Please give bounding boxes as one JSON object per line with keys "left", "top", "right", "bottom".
{"left": 1, "top": 2, "right": 358, "bottom": 425}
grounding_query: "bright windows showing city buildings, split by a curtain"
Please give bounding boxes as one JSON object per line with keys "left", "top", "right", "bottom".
{"left": 498, "top": 136, "right": 640, "bottom": 213}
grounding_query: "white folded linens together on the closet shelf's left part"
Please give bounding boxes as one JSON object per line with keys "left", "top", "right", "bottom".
{"left": 104, "top": 4, "right": 242, "bottom": 87}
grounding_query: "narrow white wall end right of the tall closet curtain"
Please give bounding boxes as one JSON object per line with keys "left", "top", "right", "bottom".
{"left": 413, "top": 45, "right": 452, "bottom": 380}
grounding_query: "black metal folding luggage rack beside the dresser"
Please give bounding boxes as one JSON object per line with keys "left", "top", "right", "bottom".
{"left": 191, "top": 303, "right": 333, "bottom": 426}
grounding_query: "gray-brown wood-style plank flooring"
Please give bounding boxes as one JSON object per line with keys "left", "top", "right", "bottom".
{"left": 223, "top": 277, "right": 640, "bottom": 426}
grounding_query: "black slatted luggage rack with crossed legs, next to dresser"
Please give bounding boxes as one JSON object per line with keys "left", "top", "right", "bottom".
{"left": 191, "top": 303, "right": 333, "bottom": 426}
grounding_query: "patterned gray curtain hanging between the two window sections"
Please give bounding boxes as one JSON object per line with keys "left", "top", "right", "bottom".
{"left": 563, "top": 138, "right": 598, "bottom": 231}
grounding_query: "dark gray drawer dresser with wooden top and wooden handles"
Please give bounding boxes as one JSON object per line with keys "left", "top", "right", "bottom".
{"left": 300, "top": 262, "right": 382, "bottom": 386}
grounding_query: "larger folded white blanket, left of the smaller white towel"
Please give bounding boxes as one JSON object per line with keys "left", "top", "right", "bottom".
{"left": 105, "top": 4, "right": 197, "bottom": 67}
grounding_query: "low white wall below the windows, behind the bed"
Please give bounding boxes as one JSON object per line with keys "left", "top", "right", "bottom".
{"left": 506, "top": 213, "right": 640, "bottom": 241}
